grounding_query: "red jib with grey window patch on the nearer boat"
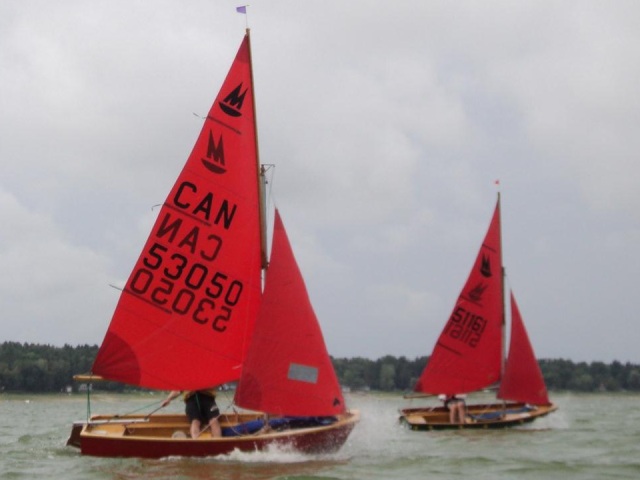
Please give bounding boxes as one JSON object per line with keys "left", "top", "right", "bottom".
{"left": 235, "top": 210, "right": 345, "bottom": 416}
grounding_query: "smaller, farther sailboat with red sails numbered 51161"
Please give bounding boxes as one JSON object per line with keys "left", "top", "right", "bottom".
{"left": 400, "top": 195, "right": 557, "bottom": 430}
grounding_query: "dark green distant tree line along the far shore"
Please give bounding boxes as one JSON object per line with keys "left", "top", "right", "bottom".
{"left": 0, "top": 342, "right": 640, "bottom": 393}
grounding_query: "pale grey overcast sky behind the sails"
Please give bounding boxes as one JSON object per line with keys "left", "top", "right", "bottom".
{"left": 0, "top": 0, "right": 640, "bottom": 363}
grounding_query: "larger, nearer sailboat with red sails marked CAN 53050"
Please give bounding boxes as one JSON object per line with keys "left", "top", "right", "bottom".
{"left": 68, "top": 30, "right": 359, "bottom": 458}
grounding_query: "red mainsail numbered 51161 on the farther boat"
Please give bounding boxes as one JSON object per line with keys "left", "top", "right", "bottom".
{"left": 415, "top": 201, "right": 504, "bottom": 395}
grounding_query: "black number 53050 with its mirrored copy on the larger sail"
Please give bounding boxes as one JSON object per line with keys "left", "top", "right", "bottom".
{"left": 129, "top": 243, "right": 243, "bottom": 332}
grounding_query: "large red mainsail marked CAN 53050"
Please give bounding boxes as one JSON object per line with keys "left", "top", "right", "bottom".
{"left": 93, "top": 36, "right": 261, "bottom": 390}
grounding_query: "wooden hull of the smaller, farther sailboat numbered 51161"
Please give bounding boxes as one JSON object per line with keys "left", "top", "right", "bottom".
{"left": 400, "top": 403, "right": 558, "bottom": 430}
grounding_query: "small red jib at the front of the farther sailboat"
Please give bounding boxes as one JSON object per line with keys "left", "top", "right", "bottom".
{"left": 498, "top": 292, "right": 549, "bottom": 405}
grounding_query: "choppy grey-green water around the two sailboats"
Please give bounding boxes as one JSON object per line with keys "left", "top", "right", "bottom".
{"left": 0, "top": 394, "right": 640, "bottom": 480}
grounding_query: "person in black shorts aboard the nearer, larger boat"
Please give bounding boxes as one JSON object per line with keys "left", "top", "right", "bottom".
{"left": 162, "top": 389, "right": 222, "bottom": 438}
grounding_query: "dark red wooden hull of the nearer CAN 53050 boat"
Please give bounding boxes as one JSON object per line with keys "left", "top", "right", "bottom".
{"left": 67, "top": 411, "right": 360, "bottom": 458}
